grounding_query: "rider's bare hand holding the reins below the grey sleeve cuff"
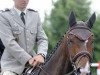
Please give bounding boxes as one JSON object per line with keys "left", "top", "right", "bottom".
{"left": 29, "top": 54, "right": 44, "bottom": 67}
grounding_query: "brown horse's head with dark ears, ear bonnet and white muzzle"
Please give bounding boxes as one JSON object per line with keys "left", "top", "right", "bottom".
{"left": 67, "top": 12, "right": 96, "bottom": 75}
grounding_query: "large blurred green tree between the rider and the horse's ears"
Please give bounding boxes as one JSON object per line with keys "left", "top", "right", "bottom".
{"left": 44, "top": 0, "right": 90, "bottom": 50}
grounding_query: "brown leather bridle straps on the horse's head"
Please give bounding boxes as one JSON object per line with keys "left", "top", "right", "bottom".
{"left": 65, "top": 26, "right": 92, "bottom": 75}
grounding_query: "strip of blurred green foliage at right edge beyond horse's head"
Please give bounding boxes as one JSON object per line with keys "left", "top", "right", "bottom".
{"left": 93, "top": 15, "right": 100, "bottom": 62}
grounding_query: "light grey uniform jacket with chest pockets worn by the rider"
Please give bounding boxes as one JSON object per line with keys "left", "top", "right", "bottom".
{"left": 0, "top": 8, "right": 48, "bottom": 74}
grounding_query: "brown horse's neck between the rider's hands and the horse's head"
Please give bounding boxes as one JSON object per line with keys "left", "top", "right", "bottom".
{"left": 44, "top": 37, "right": 67, "bottom": 75}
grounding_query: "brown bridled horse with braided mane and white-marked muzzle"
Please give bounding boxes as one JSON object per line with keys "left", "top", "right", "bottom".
{"left": 22, "top": 11, "right": 96, "bottom": 75}
